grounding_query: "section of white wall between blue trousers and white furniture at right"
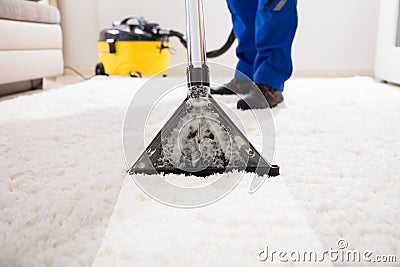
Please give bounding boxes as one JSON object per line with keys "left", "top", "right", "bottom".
{"left": 293, "top": 0, "right": 385, "bottom": 76}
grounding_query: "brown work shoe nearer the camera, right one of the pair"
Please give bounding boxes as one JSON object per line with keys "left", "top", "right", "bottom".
{"left": 237, "top": 84, "right": 283, "bottom": 110}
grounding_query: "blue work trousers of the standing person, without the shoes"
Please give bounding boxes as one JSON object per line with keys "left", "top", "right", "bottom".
{"left": 227, "top": 0, "right": 298, "bottom": 91}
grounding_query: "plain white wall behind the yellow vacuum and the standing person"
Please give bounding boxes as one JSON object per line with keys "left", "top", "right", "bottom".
{"left": 59, "top": 0, "right": 379, "bottom": 76}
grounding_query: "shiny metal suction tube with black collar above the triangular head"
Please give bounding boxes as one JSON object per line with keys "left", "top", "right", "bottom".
{"left": 186, "top": 0, "right": 210, "bottom": 92}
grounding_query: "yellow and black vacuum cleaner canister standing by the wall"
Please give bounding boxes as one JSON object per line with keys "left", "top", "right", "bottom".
{"left": 96, "top": 16, "right": 170, "bottom": 77}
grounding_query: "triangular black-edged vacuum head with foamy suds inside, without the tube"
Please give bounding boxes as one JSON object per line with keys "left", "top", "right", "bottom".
{"left": 129, "top": 95, "right": 279, "bottom": 177}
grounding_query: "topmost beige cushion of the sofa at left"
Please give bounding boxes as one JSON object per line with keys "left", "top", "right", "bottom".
{"left": 0, "top": 0, "right": 60, "bottom": 24}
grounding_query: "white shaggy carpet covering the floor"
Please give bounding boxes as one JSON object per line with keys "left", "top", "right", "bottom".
{"left": 0, "top": 77, "right": 400, "bottom": 266}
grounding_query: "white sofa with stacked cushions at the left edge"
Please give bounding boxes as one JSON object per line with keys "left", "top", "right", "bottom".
{"left": 0, "top": 0, "right": 64, "bottom": 95}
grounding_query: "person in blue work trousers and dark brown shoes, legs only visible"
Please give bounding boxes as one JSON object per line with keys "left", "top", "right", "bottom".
{"left": 211, "top": 0, "right": 298, "bottom": 110}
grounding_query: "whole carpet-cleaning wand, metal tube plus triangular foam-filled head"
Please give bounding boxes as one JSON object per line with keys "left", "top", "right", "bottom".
{"left": 129, "top": 0, "right": 279, "bottom": 177}
